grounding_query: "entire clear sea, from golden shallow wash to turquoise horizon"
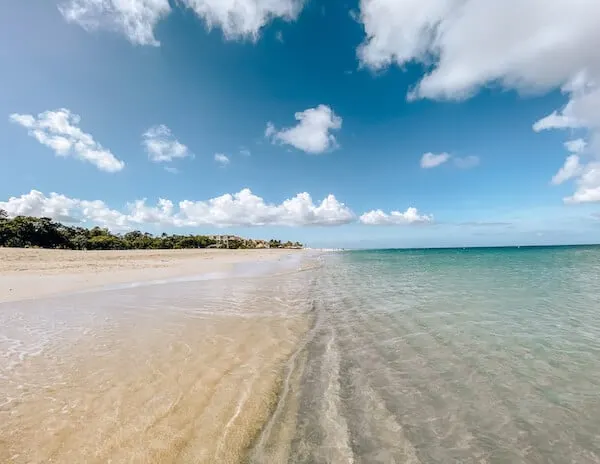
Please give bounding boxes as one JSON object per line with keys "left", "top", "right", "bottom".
{"left": 0, "top": 246, "right": 600, "bottom": 464}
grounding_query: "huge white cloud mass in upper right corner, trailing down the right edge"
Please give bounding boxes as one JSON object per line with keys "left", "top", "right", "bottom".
{"left": 357, "top": 0, "right": 600, "bottom": 203}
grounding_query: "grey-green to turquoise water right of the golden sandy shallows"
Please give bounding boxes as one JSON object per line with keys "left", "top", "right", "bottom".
{"left": 255, "top": 247, "right": 600, "bottom": 463}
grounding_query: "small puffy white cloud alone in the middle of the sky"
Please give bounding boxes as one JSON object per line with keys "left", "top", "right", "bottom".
{"left": 265, "top": 105, "right": 342, "bottom": 155}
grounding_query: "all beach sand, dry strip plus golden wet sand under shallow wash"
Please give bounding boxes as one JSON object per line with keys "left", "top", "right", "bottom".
{"left": 0, "top": 249, "right": 312, "bottom": 463}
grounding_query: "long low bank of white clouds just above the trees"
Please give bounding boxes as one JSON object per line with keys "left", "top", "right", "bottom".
{"left": 0, "top": 189, "right": 356, "bottom": 230}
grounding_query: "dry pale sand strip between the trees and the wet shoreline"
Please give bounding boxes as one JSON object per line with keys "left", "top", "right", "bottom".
{"left": 0, "top": 248, "right": 302, "bottom": 303}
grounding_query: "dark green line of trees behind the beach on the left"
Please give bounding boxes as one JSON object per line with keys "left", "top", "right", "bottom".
{"left": 0, "top": 209, "right": 302, "bottom": 250}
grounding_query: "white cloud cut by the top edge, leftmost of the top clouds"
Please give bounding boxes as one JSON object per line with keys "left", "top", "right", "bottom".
{"left": 59, "top": 0, "right": 171, "bottom": 46}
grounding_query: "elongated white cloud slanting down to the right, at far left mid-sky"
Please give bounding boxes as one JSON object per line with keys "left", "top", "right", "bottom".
{"left": 10, "top": 108, "right": 125, "bottom": 172}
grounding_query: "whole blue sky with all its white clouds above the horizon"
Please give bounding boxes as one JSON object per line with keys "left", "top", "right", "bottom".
{"left": 0, "top": 0, "right": 600, "bottom": 248}
